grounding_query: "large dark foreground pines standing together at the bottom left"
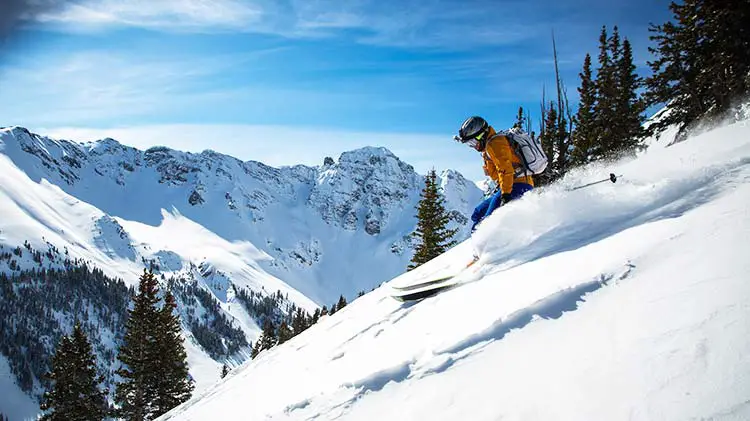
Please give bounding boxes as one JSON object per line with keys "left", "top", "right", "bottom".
{"left": 40, "top": 269, "right": 194, "bottom": 421}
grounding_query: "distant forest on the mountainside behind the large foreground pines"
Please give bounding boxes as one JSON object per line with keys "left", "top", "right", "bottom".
{"left": 0, "top": 241, "right": 250, "bottom": 419}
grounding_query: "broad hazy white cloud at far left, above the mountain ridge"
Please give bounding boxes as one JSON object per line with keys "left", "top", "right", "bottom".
{"left": 0, "top": 50, "right": 290, "bottom": 125}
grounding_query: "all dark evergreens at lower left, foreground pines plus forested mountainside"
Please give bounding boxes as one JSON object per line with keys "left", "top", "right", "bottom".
{"left": 0, "top": 242, "right": 364, "bottom": 420}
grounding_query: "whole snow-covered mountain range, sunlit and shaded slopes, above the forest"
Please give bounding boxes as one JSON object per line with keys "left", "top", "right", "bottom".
{"left": 0, "top": 127, "right": 481, "bottom": 414}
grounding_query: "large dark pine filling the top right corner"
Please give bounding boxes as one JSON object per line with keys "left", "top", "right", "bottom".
{"left": 646, "top": 0, "right": 750, "bottom": 140}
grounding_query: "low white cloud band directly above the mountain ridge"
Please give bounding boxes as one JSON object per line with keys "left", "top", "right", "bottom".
{"left": 36, "top": 124, "right": 483, "bottom": 179}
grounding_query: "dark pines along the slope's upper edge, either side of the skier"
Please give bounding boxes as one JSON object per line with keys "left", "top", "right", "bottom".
{"left": 407, "top": 0, "right": 750, "bottom": 270}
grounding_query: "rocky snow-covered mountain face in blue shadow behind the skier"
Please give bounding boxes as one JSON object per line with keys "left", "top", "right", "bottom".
{"left": 0, "top": 128, "right": 481, "bottom": 307}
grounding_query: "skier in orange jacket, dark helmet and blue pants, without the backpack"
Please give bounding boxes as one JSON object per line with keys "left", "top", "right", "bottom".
{"left": 454, "top": 116, "right": 534, "bottom": 232}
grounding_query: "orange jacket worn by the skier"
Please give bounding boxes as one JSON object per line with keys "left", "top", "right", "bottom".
{"left": 482, "top": 127, "right": 534, "bottom": 193}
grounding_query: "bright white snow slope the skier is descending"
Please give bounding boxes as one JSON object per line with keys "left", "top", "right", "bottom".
{"left": 161, "top": 118, "right": 750, "bottom": 421}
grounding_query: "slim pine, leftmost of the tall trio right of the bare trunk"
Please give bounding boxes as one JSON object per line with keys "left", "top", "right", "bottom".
{"left": 572, "top": 54, "right": 596, "bottom": 165}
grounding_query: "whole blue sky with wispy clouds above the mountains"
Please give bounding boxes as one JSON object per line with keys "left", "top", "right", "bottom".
{"left": 0, "top": 0, "right": 669, "bottom": 180}
